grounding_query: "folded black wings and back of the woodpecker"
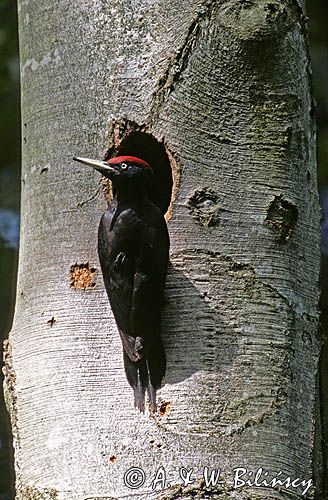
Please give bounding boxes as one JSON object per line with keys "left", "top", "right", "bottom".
{"left": 98, "top": 205, "right": 169, "bottom": 361}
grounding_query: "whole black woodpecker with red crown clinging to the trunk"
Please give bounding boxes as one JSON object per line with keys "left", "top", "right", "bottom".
{"left": 74, "top": 156, "right": 170, "bottom": 413}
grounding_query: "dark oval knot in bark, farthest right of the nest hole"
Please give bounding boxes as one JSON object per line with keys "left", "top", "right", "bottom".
{"left": 265, "top": 195, "right": 298, "bottom": 243}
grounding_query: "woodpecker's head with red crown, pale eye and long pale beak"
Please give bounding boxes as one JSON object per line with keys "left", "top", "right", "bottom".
{"left": 73, "top": 156, "right": 154, "bottom": 185}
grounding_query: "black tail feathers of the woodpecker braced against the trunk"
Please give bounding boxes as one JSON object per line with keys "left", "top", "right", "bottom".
{"left": 124, "top": 342, "right": 166, "bottom": 413}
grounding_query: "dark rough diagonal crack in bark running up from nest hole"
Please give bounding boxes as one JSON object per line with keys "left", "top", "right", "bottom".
{"left": 147, "top": 0, "right": 217, "bottom": 128}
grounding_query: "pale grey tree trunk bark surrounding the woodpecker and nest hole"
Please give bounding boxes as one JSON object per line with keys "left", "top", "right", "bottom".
{"left": 4, "top": 0, "right": 321, "bottom": 500}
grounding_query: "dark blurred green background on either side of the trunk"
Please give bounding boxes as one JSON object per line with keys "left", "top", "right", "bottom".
{"left": 0, "top": 0, "right": 328, "bottom": 500}
